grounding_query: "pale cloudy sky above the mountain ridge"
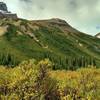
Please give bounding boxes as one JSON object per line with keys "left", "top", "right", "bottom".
{"left": 1, "top": 0, "right": 100, "bottom": 35}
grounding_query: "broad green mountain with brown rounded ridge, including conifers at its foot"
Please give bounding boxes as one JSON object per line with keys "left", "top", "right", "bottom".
{"left": 0, "top": 18, "right": 100, "bottom": 69}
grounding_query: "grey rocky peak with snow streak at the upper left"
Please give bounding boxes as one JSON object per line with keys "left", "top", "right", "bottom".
{"left": 0, "top": 2, "right": 17, "bottom": 19}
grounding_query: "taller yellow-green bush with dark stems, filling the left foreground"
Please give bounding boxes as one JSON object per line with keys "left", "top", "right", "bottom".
{"left": 0, "top": 60, "right": 57, "bottom": 100}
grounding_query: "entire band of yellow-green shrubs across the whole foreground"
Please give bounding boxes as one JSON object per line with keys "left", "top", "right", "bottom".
{"left": 0, "top": 59, "right": 100, "bottom": 100}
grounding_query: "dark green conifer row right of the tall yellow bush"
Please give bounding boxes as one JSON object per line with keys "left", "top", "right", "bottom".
{"left": 45, "top": 54, "right": 96, "bottom": 70}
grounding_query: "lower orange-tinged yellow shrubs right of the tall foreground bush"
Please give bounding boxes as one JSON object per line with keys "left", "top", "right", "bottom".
{"left": 50, "top": 68, "right": 100, "bottom": 100}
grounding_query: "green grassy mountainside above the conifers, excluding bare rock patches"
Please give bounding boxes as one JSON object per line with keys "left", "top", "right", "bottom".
{"left": 0, "top": 19, "right": 100, "bottom": 68}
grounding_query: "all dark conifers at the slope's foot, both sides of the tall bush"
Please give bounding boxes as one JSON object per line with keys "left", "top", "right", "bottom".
{"left": 0, "top": 52, "right": 96, "bottom": 70}
